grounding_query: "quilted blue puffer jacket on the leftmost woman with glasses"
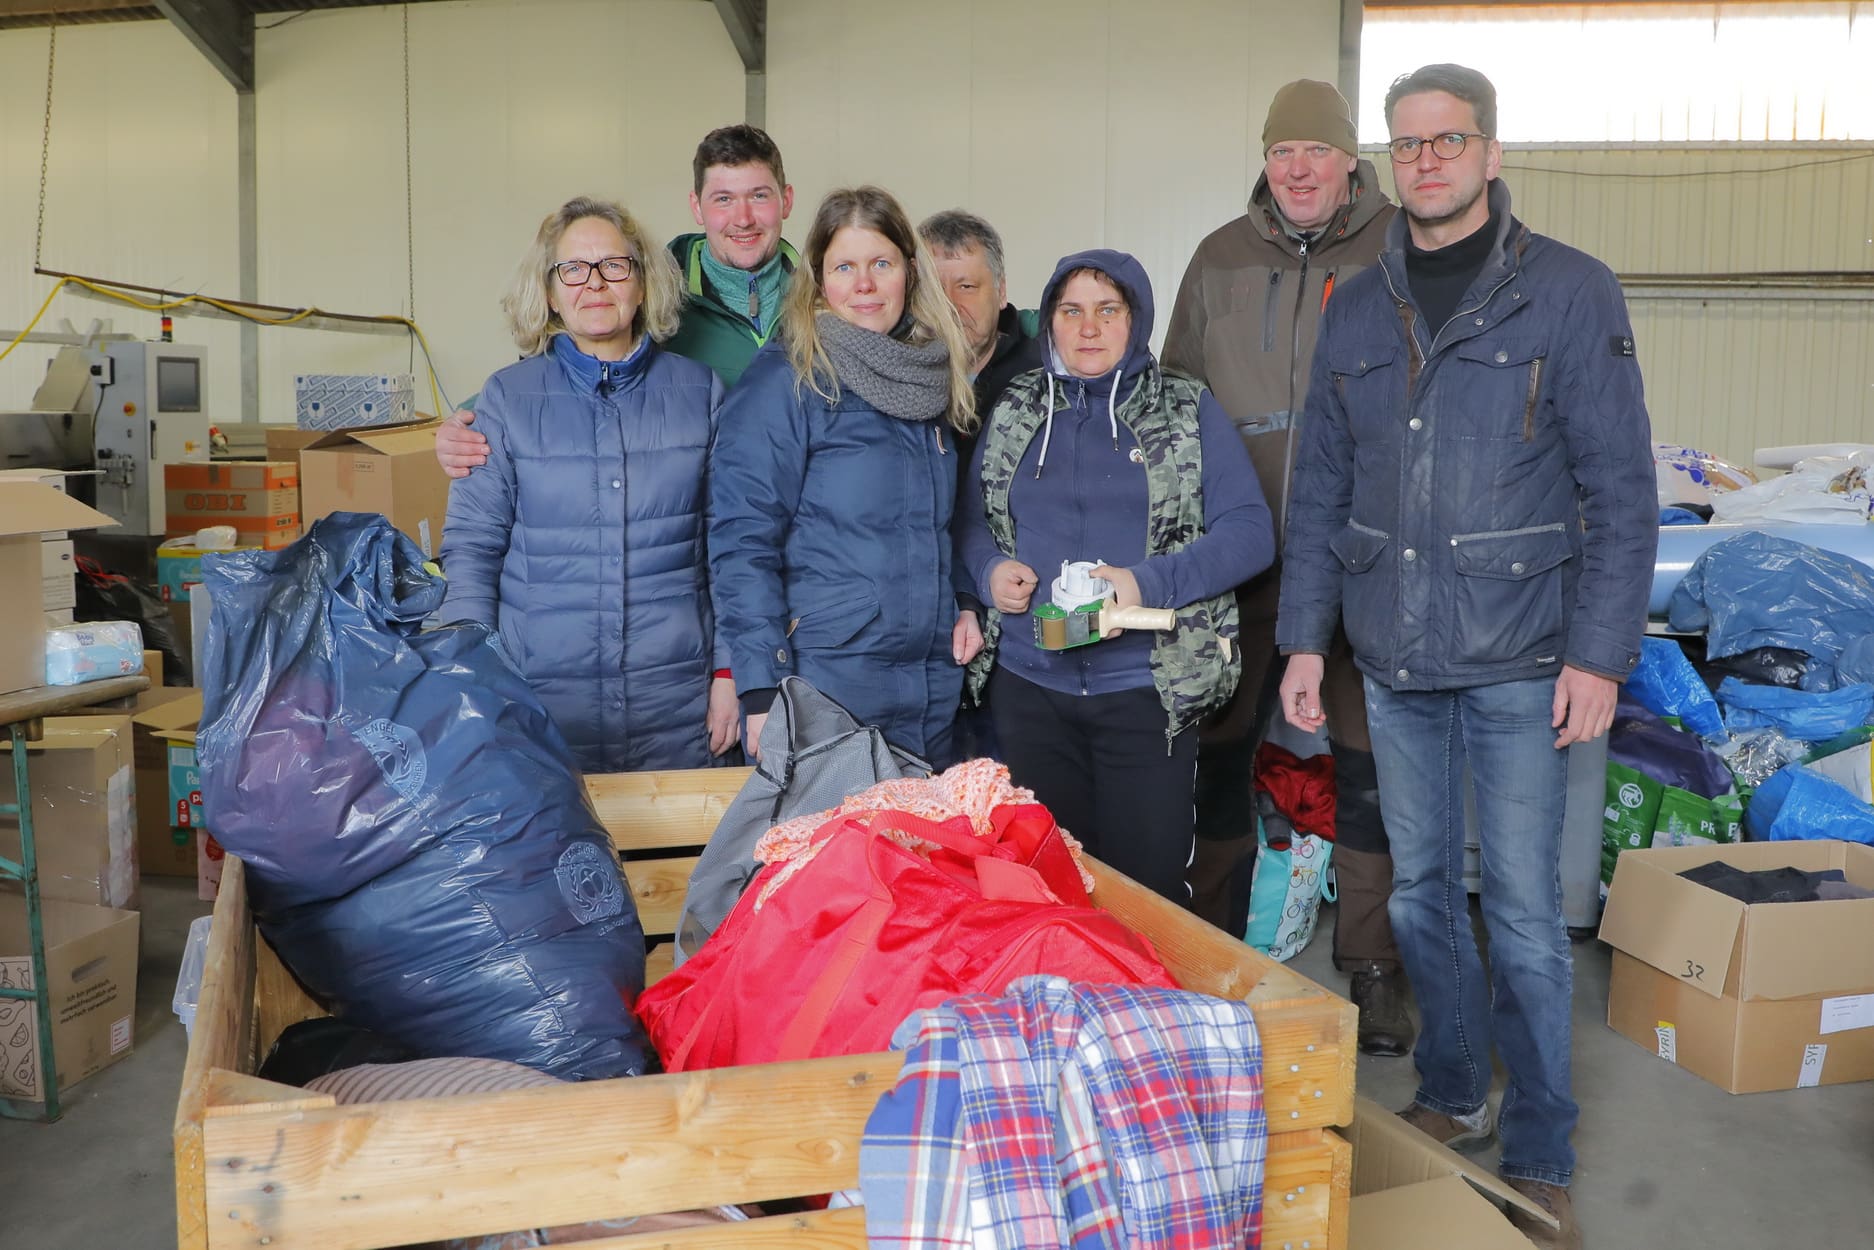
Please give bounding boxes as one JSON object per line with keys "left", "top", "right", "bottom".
{"left": 442, "top": 335, "right": 727, "bottom": 772}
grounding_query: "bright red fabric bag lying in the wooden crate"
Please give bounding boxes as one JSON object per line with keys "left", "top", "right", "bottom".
{"left": 637, "top": 804, "right": 1177, "bottom": 1072}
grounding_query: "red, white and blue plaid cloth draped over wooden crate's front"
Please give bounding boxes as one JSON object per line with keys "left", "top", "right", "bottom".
{"left": 858, "top": 976, "right": 1269, "bottom": 1250}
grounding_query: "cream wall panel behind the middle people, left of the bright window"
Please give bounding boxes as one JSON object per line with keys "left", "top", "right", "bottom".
{"left": 768, "top": 0, "right": 1340, "bottom": 339}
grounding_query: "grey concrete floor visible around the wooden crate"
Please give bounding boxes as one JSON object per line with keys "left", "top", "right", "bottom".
{"left": 0, "top": 879, "right": 1874, "bottom": 1250}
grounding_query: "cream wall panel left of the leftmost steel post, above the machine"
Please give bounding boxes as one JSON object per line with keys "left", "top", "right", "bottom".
{"left": 0, "top": 22, "right": 240, "bottom": 418}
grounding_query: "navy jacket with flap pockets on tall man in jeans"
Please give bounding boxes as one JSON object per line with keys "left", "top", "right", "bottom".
{"left": 1276, "top": 180, "right": 1658, "bottom": 690}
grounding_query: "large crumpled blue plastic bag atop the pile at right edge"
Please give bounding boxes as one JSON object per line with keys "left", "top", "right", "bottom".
{"left": 1666, "top": 530, "right": 1874, "bottom": 690}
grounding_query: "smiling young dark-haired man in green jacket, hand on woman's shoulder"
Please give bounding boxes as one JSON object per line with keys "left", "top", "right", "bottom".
{"left": 437, "top": 126, "right": 795, "bottom": 478}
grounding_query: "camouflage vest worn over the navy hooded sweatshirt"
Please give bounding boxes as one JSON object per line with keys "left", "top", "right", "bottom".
{"left": 969, "top": 364, "right": 1242, "bottom": 738}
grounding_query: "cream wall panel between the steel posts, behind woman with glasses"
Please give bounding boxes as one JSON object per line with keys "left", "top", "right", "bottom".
{"left": 255, "top": 0, "right": 744, "bottom": 420}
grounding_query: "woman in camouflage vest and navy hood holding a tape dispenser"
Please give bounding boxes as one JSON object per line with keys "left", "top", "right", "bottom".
{"left": 958, "top": 251, "right": 1274, "bottom": 901}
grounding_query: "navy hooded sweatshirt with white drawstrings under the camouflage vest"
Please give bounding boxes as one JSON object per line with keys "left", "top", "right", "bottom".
{"left": 956, "top": 249, "right": 1274, "bottom": 695}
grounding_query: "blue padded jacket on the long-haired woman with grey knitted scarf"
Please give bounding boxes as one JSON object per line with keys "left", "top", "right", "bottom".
{"left": 710, "top": 341, "right": 963, "bottom": 757}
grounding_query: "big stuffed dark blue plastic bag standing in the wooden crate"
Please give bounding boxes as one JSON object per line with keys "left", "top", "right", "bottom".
{"left": 197, "top": 513, "right": 650, "bottom": 1079}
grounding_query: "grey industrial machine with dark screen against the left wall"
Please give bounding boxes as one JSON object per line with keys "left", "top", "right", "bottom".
{"left": 0, "top": 335, "right": 210, "bottom": 538}
